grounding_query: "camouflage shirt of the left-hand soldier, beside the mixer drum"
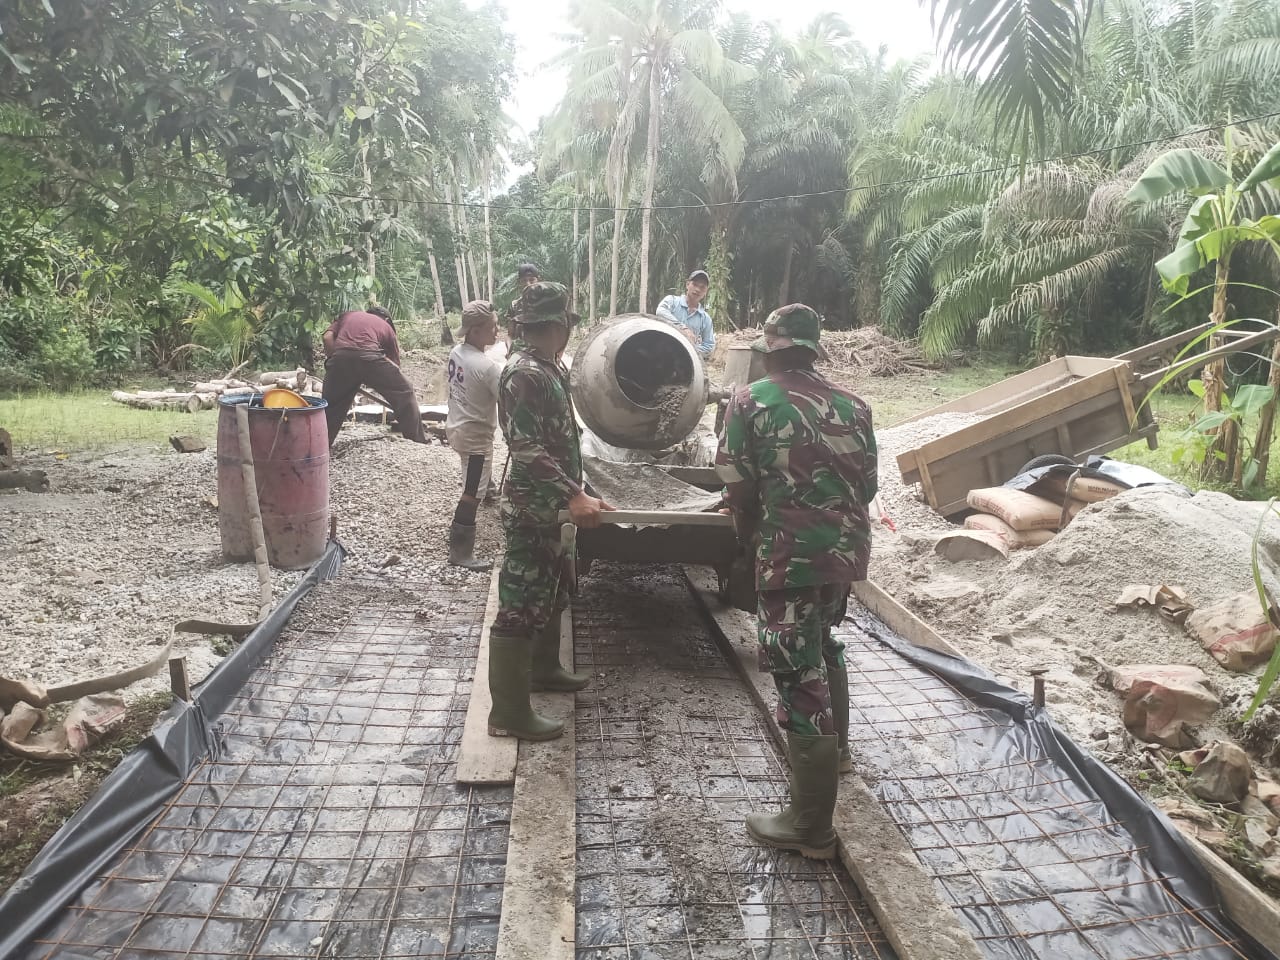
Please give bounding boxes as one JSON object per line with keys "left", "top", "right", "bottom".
{"left": 498, "top": 343, "right": 582, "bottom": 526}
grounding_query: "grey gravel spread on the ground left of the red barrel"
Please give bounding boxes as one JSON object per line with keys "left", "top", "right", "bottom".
{"left": 0, "top": 450, "right": 302, "bottom": 695}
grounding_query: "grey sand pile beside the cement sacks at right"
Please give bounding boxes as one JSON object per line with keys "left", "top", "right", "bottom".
{"left": 870, "top": 488, "right": 1280, "bottom": 749}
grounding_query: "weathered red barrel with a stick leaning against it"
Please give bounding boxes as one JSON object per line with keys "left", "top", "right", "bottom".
{"left": 218, "top": 394, "right": 329, "bottom": 570}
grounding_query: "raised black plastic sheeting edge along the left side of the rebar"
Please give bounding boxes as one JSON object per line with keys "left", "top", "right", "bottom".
{"left": 0, "top": 541, "right": 346, "bottom": 960}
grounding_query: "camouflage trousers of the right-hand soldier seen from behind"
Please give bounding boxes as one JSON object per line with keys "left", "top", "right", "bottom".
{"left": 756, "top": 584, "right": 849, "bottom": 736}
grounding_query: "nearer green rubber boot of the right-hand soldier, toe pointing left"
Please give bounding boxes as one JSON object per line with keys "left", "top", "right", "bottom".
{"left": 746, "top": 732, "right": 840, "bottom": 860}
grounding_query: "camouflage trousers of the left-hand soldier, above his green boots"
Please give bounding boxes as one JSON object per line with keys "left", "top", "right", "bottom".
{"left": 493, "top": 522, "right": 568, "bottom": 636}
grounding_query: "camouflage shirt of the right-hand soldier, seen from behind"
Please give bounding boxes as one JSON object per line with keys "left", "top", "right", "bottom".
{"left": 716, "top": 370, "right": 877, "bottom": 590}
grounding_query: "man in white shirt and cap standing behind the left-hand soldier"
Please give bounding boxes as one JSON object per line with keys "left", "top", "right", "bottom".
{"left": 444, "top": 300, "right": 502, "bottom": 570}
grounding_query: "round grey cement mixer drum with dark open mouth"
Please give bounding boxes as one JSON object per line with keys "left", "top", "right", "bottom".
{"left": 570, "top": 314, "right": 707, "bottom": 451}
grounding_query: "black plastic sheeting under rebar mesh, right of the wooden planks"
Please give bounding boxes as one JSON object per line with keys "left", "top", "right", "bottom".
{"left": 841, "top": 608, "right": 1275, "bottom": 960}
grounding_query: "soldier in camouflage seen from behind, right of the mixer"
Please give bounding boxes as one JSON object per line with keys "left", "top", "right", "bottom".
{"left": 716, "top": 303, "right": 877, "bottom": 859}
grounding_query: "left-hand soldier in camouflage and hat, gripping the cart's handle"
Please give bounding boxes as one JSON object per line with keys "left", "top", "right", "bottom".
{"left": 489, "top": 283, "right": 612, "bottom": 740}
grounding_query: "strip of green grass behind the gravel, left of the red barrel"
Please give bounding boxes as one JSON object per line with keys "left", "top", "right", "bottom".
{"left": 0, "top": 390, "right": 218, "bottom": 456}
